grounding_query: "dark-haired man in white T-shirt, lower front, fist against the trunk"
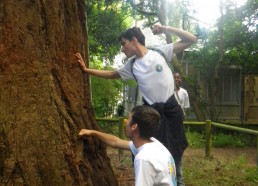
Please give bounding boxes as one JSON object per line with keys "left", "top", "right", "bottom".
{"left": 79, "top": 106, "right": 177, "bottom": 186}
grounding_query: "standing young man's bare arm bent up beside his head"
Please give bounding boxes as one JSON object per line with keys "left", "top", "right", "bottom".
{"left": 152, "top": 25, "right": 197, "bottom": 53}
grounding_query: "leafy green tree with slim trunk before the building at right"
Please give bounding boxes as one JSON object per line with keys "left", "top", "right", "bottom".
{"left": 186, "top": 0, "right": 258, "bottom": 121}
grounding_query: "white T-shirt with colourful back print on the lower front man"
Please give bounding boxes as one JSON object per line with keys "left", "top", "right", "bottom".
{"left": 129, "top": 137, "right": 176, "bottom": 186}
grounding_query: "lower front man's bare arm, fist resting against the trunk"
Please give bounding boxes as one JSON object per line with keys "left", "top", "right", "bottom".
{"left": 79, "top": 129, "right": 130, "bottom": 150}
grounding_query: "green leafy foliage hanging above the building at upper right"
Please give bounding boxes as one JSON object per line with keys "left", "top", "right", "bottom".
{"left": 188, "top": 0, "right": 258, "bottom": 76}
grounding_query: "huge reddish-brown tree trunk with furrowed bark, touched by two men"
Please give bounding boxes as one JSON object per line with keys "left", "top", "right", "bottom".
{"left": 0, "top": 0, "right": 117, "bottom": 186}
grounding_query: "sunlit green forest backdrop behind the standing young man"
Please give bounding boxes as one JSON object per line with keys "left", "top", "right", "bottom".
{"left": 87, "top": 0, "right": 258, "bottom": 121}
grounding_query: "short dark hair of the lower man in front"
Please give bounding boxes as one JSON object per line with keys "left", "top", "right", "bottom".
{"left": 130, "top": 105, "right": 160, "bottom": 139}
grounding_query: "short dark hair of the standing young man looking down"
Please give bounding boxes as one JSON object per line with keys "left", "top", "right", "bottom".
{"left": 118, "top": 27, "right": 145, "bottom": 46}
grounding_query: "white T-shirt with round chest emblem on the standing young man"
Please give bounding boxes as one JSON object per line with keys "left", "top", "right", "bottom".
{"left": 117, "top": 44, "right": 174, "bottom": 104}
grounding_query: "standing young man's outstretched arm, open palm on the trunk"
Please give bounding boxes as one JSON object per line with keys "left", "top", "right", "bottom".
{"left": 75, "top": 53, "right": 120, "bottom": 79}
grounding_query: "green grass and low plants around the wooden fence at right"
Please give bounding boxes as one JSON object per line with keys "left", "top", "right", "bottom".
{"left": 183, "top": 125, "right": 258, "bottom": 186}
